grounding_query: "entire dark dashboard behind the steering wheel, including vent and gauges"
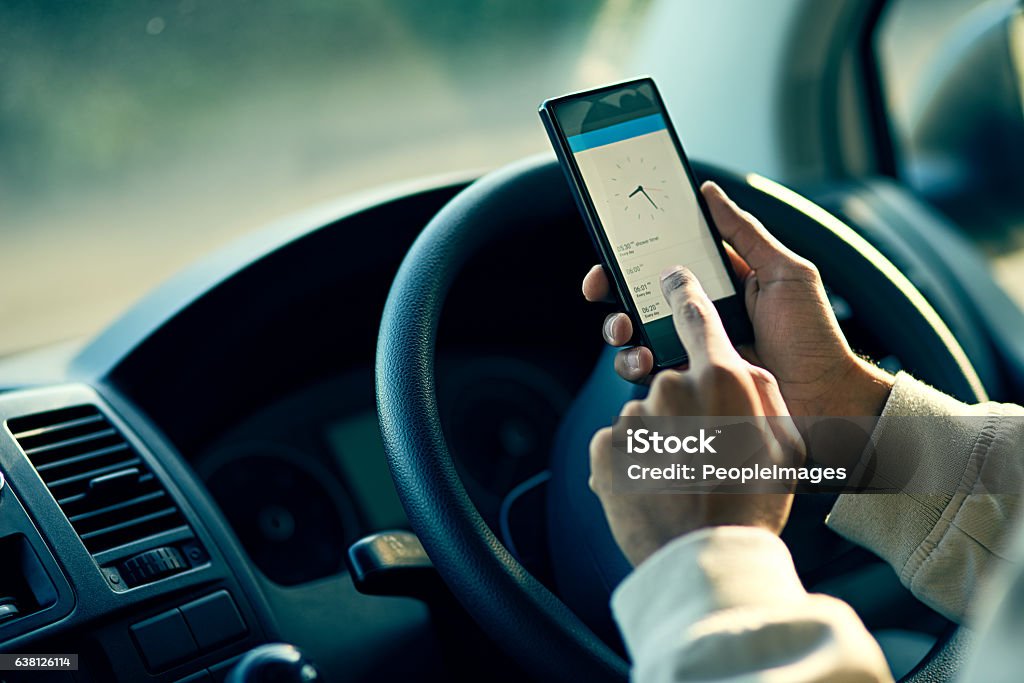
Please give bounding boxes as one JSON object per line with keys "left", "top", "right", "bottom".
{"left": 0, "top": 172, "right": 603, "bottom": 683}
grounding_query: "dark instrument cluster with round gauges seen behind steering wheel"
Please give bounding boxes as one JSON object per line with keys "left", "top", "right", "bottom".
{"left": 191, "top": 351, "right": 573, "bottom": 586}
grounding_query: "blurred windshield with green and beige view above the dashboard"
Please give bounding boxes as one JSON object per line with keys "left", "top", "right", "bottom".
{"left": 0, "top": 0, "right": 647, "bottom": 354}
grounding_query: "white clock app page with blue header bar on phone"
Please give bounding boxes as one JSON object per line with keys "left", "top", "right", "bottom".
{"left": 567, "top": 114, "right": 735, "bottom": 324}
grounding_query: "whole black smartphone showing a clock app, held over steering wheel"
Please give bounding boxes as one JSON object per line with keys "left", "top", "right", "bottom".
{"left": 540, "top": 78, "right": 753, "bottom": 369}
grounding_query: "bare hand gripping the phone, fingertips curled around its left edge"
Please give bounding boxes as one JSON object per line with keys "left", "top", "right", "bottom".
{"left": 583, "top": 112, "right": 894, "bottom": 416}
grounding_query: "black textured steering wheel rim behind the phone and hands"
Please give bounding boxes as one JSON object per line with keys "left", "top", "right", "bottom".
{"left": 376, "top": 157, "right": 985, "bottom": 683}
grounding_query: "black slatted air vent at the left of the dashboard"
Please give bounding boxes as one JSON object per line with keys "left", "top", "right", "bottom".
{"left": 7, "top": 405, "right": 185, "bottom": 555}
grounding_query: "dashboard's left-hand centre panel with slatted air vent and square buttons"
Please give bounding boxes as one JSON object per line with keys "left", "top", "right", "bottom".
{"left": 0, "top": 384, "right": 271, "bottom": 681}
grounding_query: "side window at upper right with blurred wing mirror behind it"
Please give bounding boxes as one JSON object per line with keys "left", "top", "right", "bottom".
{"left": 876, "top": 0, "right": 1024, "bottom": 304}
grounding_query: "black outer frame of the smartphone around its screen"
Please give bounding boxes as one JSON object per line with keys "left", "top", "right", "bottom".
{"left": 538, "top": 76, "right": 752, "bottom": 370}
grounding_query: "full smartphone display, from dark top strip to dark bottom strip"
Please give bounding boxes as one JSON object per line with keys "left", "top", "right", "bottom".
{"left": 554, "top": 82, "right": 736, "bottom": 359}
